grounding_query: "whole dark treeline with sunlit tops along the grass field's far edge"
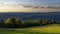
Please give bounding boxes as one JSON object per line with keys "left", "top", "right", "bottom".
{"left": 0, "top": 18, "right": 56, "bottom": 28}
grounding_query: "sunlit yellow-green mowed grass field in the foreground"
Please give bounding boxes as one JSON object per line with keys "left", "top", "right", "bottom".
{"left": 0, "top": 24, "right": 60, "bottom": 34}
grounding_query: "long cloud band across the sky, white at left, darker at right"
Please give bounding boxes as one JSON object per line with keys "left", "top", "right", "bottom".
{"left": 0, "top": 2, "right": 60, "bottom": 9}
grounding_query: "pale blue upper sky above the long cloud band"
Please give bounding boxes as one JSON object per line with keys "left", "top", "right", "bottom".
{"left": 0, "top": 0, "right": 60, "bottom": 6}
